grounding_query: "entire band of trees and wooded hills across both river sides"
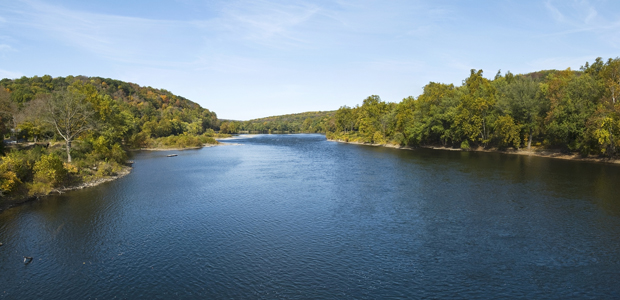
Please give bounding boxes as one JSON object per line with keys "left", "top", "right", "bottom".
{"left": 0, "top": 58, "right": 620, "bottom": 200}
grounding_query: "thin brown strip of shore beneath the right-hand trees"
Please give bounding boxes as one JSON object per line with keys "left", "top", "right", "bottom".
{"left": 328, "top": 139, "right": 620, "bottom": 164}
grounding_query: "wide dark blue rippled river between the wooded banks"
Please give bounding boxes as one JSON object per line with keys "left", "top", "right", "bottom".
{"left": 0, "top": 135, "right": 620, "bottom": 299}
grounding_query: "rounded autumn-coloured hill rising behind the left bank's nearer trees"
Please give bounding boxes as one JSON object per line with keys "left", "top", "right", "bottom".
{"left": 0, "top": 75, "right": 219, "bottom": 142}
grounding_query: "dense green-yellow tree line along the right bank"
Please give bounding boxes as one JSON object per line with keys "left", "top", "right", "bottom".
{"left": 326, "top": 58, "right": 620, "bottom": 157}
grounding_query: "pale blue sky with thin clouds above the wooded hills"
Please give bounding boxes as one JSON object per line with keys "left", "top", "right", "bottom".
{"left": 0, "top": 0, "right": 620, "bottom": 120}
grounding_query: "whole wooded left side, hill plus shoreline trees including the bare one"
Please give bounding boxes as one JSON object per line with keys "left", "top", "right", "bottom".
{"left": 0, "top": 75, "right": 219, "bottom": 200}
